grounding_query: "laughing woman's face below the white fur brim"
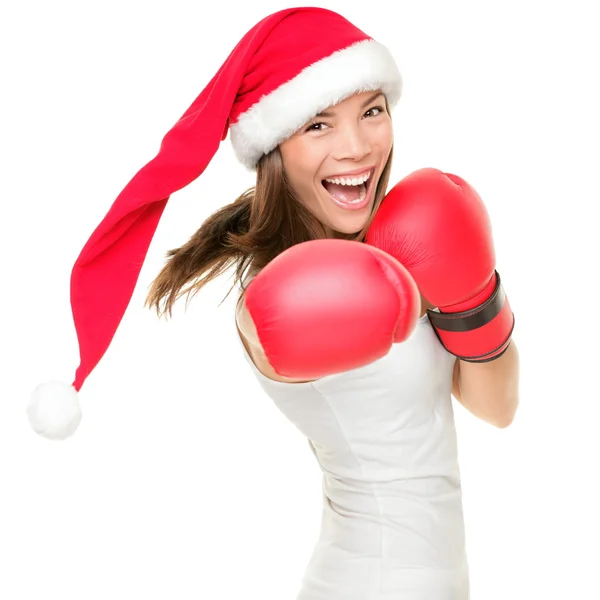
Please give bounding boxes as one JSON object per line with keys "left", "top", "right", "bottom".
{"left": 279, "top": 92, "right": 393, "bottom": 235}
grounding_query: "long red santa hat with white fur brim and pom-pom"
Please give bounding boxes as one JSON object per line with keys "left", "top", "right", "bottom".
{"left": 27, "top": 7, "right": 402, "bottom": 439}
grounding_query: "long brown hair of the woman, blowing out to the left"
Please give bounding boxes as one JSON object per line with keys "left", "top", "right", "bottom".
{"left": 145, "top": 148, "right": 393, "bottom": 317}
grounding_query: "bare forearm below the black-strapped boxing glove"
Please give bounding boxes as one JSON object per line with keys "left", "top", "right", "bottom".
{"left": 454, "top": 341, "right": 519, "bottom": 428}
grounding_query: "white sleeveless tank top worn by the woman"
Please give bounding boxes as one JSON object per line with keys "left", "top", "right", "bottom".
{"left": 234, "top": 316, "right": 469, "bottom": 600}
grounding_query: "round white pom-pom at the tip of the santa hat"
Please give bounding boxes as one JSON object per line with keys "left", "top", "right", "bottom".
{"left": 27, "top": 381, "right": 82, "bottom": 440}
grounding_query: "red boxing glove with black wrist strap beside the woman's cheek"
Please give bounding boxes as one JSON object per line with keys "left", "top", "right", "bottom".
{"left": 366, "top": 168, "right": 514, "bottom": 362}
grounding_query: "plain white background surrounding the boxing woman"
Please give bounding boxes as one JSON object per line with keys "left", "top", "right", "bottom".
{"left": 0, "top": 0, "right": 600, "bottom": 600}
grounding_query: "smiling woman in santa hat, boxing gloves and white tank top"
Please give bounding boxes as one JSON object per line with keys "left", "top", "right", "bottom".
{"left": 29, "top": 8, "right": 517, "bottom": 600}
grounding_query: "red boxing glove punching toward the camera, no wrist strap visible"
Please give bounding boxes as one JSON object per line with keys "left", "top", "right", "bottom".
{"left": 244, "top": 239, "right": 420, "bottom": 380}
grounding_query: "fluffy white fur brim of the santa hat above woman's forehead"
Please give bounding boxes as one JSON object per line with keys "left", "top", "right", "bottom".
{"left": 230, "top": 40, "right": 402, "bottom": 170}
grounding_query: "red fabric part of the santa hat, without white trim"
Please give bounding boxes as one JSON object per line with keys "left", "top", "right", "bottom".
{"left": 71, "top": 8, "right": 364, "bottom": 390}
